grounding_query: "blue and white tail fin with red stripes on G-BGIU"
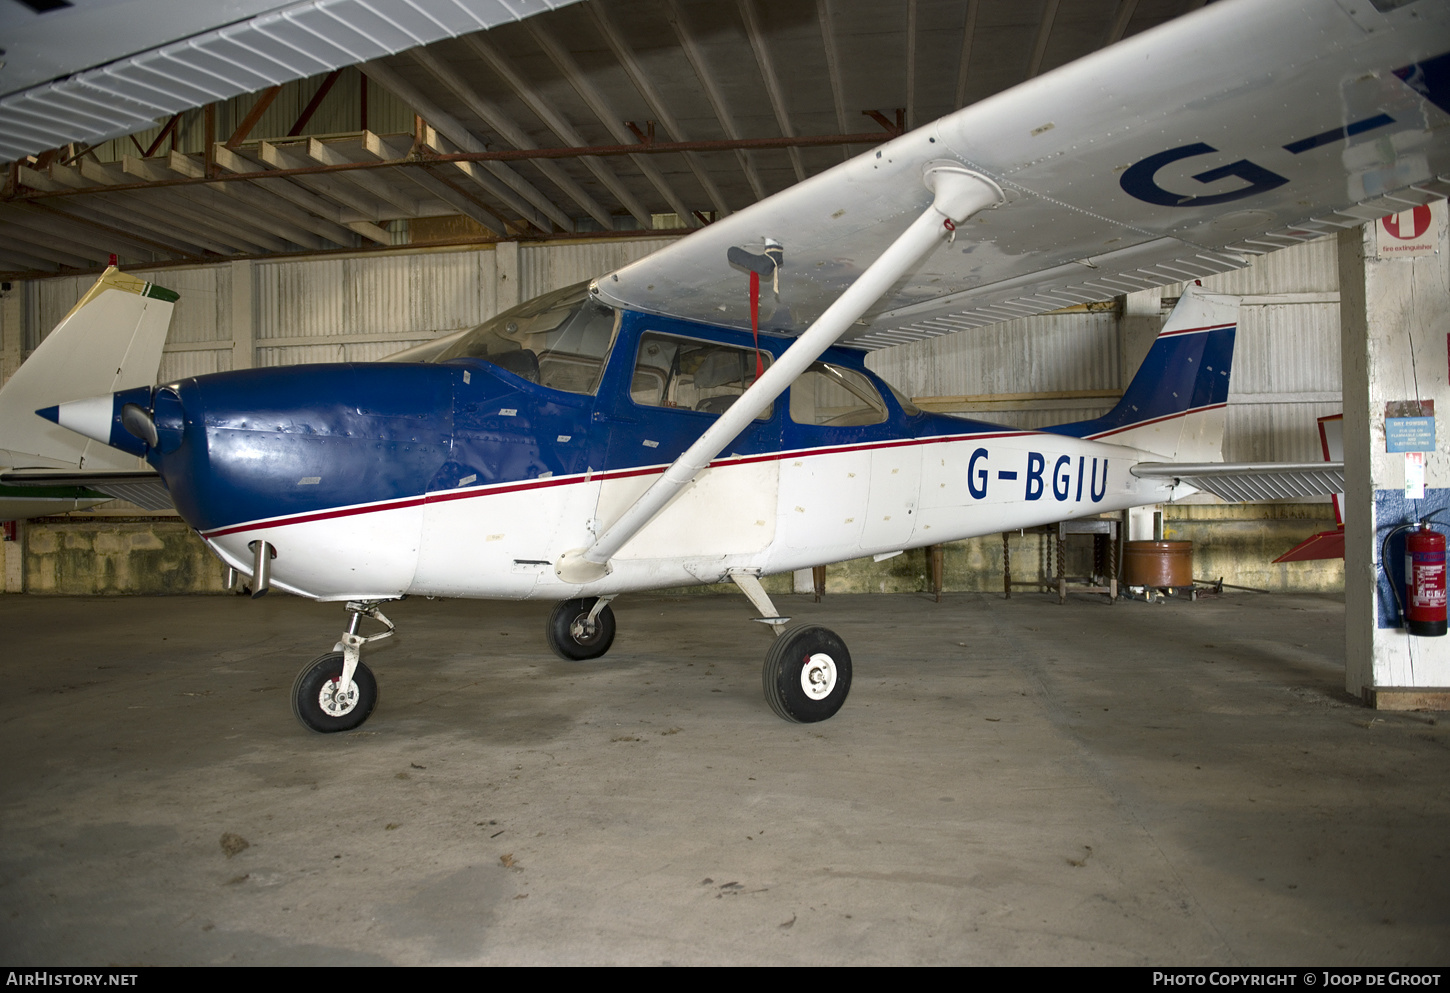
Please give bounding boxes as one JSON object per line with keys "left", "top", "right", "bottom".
{"left": 1044, "top": 286, "right": 1238, "bottom": 462}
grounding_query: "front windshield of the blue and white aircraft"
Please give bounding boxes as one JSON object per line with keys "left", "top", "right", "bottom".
{"left": 434, "top": 283, "right": 619, "bottom": 396}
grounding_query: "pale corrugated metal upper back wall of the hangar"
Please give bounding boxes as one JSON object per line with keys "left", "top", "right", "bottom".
{"left": 25, "top": 238, "right": 1340, "bottom": 461}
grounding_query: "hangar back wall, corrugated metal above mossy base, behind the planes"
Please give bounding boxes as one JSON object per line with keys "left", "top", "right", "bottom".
{"left": 0, "top": 238, "right": 1343, "bottom": 594}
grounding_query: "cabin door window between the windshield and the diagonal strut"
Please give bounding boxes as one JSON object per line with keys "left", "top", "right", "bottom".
{"left": 629, "top": 331, "right": 774, "bottom": 420}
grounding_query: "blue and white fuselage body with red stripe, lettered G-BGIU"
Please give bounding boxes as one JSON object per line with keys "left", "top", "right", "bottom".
{"left": 136, "top": 312, "right": 1167, "bottom": 600}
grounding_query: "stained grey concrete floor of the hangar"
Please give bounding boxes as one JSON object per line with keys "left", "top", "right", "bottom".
{"left": 0, "top": 594, "right": 1450, "bottom": 965}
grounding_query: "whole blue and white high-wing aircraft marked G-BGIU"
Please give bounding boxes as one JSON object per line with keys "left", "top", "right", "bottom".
{"left": 25, "top": 0, "right": 1450, "bottom": 732}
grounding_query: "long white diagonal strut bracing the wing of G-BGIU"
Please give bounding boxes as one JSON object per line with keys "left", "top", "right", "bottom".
{"left": 554, "top": 162, "right": 1003, "bottom": 583}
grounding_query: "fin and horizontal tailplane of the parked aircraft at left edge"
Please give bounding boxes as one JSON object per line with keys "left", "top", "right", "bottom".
{"left": 0, "top": 267, "right": 178, "bottom": 520}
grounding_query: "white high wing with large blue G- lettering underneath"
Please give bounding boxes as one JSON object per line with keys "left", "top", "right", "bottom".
{"left": 599, "top": 0, "right": 1450, "bottom": 348}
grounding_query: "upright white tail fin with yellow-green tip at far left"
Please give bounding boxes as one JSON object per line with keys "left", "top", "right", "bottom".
{"left": 0, "top": 267, "right": 180, "bottom": 470}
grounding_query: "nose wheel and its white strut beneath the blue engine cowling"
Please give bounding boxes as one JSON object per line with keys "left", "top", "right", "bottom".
{"left": 291, "top": 600, "right": 394, "bottom": 735}
